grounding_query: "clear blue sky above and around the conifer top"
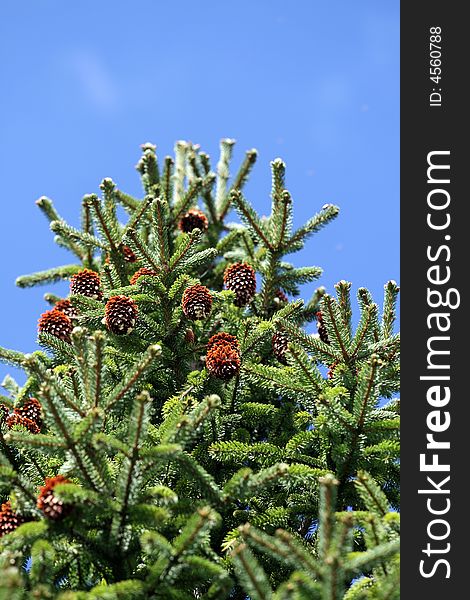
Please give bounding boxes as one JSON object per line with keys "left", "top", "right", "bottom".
{"left": 0, "top": 0, "right": 399, "bottom": 378}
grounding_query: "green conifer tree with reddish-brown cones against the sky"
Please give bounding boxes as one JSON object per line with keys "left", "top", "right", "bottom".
{"left": 0, "top": 139, "right": 399, "bottom": 600}
